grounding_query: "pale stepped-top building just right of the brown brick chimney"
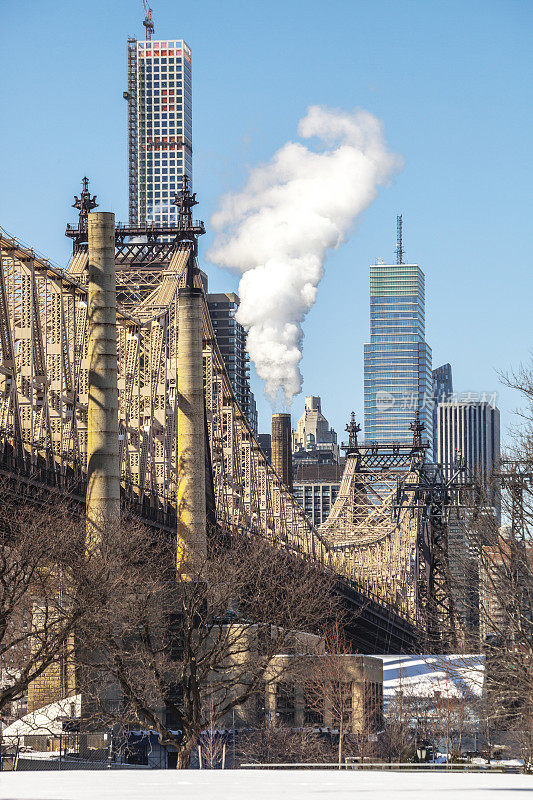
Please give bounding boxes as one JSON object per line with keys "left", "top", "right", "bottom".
{"left": 292, "top": 397, "right": 339, "bottom": 469}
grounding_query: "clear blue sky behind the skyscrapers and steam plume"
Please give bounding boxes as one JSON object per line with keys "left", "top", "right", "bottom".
{"left": 0, "top": 0, "right": 533, "bottom": 444}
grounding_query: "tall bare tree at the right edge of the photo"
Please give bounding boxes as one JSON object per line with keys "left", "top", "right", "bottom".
{"left": 442, "top": 363, "right": 533, "bottom": 763}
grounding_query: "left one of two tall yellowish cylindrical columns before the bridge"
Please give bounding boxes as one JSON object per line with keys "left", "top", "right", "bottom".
{"left": 86, "top": 211, "right": 120, "bottom": 545}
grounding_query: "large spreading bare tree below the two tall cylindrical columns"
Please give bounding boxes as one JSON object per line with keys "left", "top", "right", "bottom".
{"left": 79, "top": 531, "right": 334, "bottom": 767}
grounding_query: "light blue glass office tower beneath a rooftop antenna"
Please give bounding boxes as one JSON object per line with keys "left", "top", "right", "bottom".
{"left": 364, "top": 264, "right": 433, "bottom": 442}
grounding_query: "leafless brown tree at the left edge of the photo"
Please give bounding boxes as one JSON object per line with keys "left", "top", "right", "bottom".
{"left": 0, "top": 483, "right": 101, "bottom": 711}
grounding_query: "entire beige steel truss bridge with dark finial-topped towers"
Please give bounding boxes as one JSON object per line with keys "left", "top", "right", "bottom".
{"left": 0, "top": 180, "right": 461, "bottom": 653}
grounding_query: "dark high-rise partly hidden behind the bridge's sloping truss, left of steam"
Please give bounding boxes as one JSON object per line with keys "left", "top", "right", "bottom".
{"left": 207, "top": 292, "right": 257, "bottom": 434}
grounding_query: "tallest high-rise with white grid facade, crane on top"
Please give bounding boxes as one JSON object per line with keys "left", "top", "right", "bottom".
{"left": 124, "top": 38, "right": 192, "bottom": 225}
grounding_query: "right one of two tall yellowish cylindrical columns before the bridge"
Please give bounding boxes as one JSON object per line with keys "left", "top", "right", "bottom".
{"left": 177, "top": 287, "right": 207, "bottom": 573}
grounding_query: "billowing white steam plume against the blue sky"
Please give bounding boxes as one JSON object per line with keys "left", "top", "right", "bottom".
{"left": 207, "top": 106, "right": 401, "bottom": 404}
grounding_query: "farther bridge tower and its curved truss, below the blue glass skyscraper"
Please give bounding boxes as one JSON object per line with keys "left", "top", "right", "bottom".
{"left": 319, "top": 414, "right": 472, "bottom": 646}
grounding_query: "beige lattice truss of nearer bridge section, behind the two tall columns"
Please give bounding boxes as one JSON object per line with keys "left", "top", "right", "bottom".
{"left": 0, "top": 225, "right": 334, "bottom": 580}
